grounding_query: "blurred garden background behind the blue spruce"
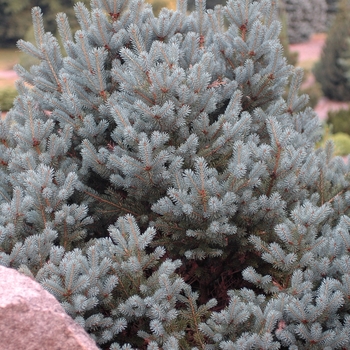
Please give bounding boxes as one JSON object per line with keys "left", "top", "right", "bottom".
{"left": 0, "top": 0, "right": 350, "bottom": 156}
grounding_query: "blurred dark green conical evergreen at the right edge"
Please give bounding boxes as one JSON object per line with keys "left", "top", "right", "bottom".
{"left": 314, "top": 0, "right": 350, "bottom": 101}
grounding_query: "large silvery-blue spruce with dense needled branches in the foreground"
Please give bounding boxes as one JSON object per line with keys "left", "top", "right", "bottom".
{"left": 0, "top": 0, "right": 350, "bottom": 350}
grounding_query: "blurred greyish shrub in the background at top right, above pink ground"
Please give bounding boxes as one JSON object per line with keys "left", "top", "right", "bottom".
{"left": 282, "top": 0, "right": 327, "bottom": 44}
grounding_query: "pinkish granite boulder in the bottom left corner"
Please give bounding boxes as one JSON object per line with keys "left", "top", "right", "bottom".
{"left": 0, "top": 266, "right": 98, "bottom": 350}
